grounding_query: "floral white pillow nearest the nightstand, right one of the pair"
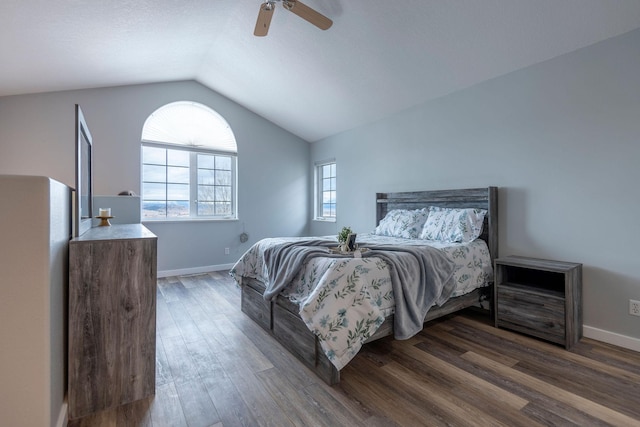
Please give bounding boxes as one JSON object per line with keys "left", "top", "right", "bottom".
{"left": 420, "top": 206, "right": 487, "bottom": 243}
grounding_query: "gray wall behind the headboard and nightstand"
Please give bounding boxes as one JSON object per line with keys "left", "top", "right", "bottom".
{"left": 310, "top": 31, "right": 640, "bottom": 344}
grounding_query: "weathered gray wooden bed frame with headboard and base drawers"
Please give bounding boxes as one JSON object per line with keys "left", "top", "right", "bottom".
{"left": 241, "top": 187, "right": 498, "bottom": 385}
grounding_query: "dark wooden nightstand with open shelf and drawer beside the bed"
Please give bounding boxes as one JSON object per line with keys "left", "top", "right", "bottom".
{"left": 494, "top": 256, "right": 582, "bottom": 350}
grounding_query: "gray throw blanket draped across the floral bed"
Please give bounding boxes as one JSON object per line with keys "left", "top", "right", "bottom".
{"left": 264, "top": 239, "right": 455, "bottom": 339}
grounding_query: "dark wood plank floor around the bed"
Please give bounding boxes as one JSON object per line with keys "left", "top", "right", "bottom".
{"left": 69, "top": 273, "right": 640, "bottom": 427}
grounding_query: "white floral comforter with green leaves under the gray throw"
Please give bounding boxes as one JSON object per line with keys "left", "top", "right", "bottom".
{"left": 230, "top": 235, "right": 492, "bottom": 369}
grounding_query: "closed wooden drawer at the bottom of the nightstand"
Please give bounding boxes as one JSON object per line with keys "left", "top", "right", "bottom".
{"left": 496, "top": 285, "right": 565, "bottom": 344}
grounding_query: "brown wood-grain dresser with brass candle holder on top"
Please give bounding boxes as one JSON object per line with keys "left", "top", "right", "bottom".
{"left": 68, "top": 224, "right": 157, "bottom": 419}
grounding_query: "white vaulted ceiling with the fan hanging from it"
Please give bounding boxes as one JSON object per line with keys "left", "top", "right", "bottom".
{"left": 0, "top": 0, "right": 640, "bottom": 142}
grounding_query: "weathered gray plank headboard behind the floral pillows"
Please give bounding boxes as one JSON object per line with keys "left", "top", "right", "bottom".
{"left": 376, "top": 187, "right": 498, "bottom": 259}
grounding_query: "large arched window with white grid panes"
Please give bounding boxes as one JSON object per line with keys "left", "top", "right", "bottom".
{"left": 142, "top": 101, "right": 238, "bottom": 220}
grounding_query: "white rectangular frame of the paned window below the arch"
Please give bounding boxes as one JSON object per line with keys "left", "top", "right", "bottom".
{"left": 140, "top": 140, "right": 238, "bottom": 222}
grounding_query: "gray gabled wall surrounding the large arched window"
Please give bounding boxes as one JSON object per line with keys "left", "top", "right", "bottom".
{"left": 0, "top": 81, "right": 310, "bottom": 271}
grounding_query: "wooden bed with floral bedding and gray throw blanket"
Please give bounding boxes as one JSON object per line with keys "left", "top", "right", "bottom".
{"left": 231, "top": 187, "right": 498, "bottom": 385}
